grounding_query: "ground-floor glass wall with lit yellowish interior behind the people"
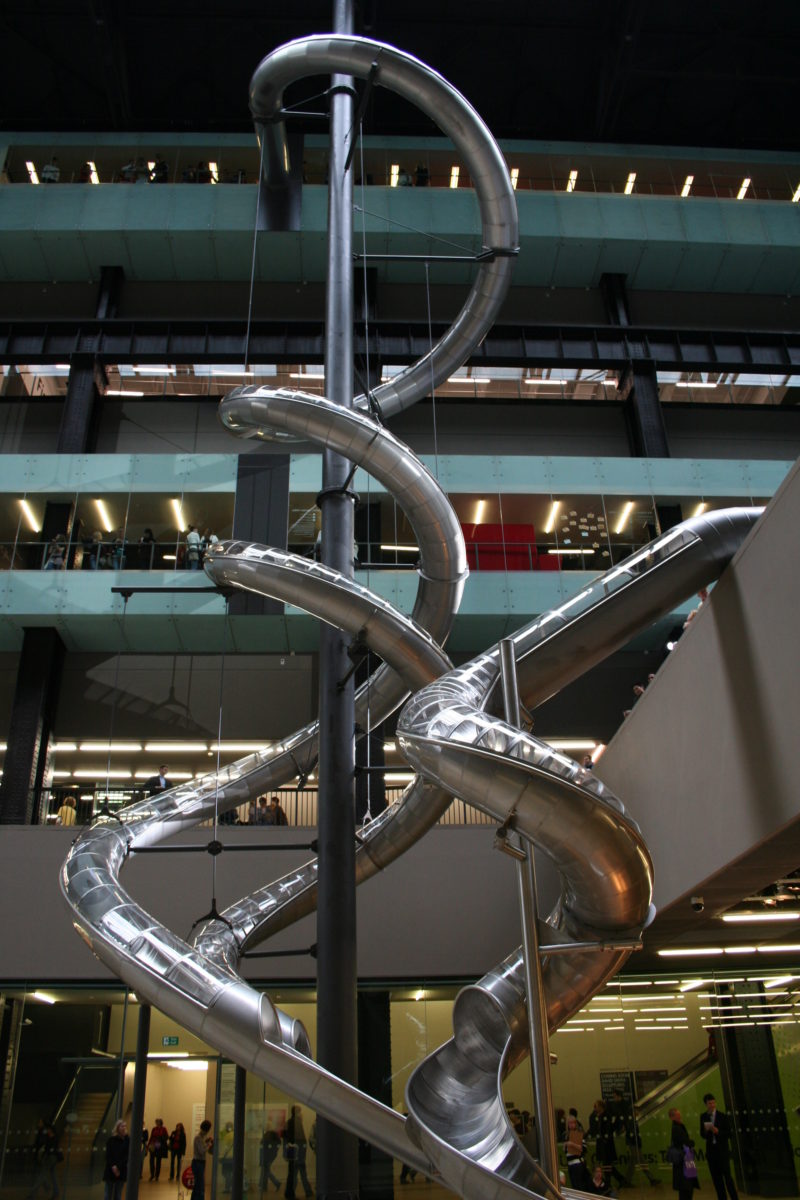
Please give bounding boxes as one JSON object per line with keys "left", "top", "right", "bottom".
{"left": 0, "top": 974, "right": 800, "bottom": 1198}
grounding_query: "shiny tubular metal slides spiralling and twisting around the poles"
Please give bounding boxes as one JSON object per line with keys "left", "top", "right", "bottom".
{"left": 61, "top": 36, "right": 758, "bottom": 1200}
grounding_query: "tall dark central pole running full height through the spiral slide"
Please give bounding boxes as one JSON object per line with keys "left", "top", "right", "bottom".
{"left": 317, "top": 0, "right": 359, "bottom": 1200}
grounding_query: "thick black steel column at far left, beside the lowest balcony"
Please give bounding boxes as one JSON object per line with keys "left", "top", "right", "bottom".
{"left": 0, "top": 628, "right": 65, "bottom": 824}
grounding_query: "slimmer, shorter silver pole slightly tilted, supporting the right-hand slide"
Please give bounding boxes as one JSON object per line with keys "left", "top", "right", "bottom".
{"left": 500, "top": 637, "right": 559, "bottom": 1192}
